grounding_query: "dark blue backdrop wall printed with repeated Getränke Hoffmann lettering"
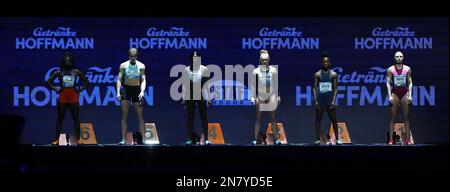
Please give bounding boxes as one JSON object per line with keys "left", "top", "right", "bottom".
{"left": 0, "top": 18, "right": 449, "bottom": 144}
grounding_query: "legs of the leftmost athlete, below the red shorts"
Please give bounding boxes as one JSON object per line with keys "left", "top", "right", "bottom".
{"left": 55, "top": 102, "right": 80, "bottom": 140}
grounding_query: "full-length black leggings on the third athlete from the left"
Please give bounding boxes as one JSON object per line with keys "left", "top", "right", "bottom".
{"left": 185, "top": 100, "right": 208, "bottom": 140}
